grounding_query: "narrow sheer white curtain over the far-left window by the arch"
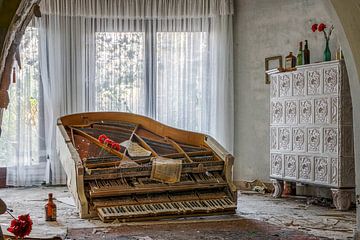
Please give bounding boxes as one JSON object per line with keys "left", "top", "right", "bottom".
{"left": 0, "top": 26, "right": 46, "bottom": 186}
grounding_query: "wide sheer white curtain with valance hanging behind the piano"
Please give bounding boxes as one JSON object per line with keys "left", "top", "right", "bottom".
{"left": 36, "top": 0, "right": 234, "bottom": 183}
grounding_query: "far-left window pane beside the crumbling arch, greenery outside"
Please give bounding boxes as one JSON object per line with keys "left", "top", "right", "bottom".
{"left": 0, "top": 27, "right": 40, "bottom": 166}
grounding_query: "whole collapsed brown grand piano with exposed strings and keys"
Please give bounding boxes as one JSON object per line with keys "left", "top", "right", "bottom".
{"left": 57, "top": 112, "right": 237, "bottom": 222}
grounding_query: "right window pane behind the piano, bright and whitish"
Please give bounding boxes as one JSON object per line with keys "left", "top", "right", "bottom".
{"left": 156, "top": 32, "right": 208, "bottom": 132}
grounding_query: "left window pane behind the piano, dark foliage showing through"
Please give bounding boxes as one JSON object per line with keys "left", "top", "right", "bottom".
{"left": 95, "top": 32, "right": 145, "bottom": 114}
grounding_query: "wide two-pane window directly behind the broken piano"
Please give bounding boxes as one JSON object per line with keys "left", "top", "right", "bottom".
{"left": 90, "top": 27, "right": 208, "bottom": 131}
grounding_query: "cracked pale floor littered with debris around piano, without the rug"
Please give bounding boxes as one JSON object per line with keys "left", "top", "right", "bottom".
{"left": 0, "top": 187, "right": 355, "bottom": 240}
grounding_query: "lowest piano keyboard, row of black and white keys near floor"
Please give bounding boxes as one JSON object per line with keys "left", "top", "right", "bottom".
{"left": 97, "top": 198, "right": 236, "bottom": 222}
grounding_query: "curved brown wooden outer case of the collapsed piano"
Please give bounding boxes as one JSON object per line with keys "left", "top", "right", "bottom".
{"left": 57, "top": 112, "right": 237, "bottom": 218}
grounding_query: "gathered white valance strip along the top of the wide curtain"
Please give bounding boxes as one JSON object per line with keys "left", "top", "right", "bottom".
{"left": 41, "top": 0, "right": 234, "bottom": 20}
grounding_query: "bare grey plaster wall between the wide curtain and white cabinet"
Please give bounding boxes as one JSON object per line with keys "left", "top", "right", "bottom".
{"left": 234, "top": 0, "right": 339, "bottom": 181}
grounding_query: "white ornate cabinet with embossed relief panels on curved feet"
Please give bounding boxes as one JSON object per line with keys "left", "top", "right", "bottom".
{"left": 267, "top": 61, "right": 355, "bottom": 210}
